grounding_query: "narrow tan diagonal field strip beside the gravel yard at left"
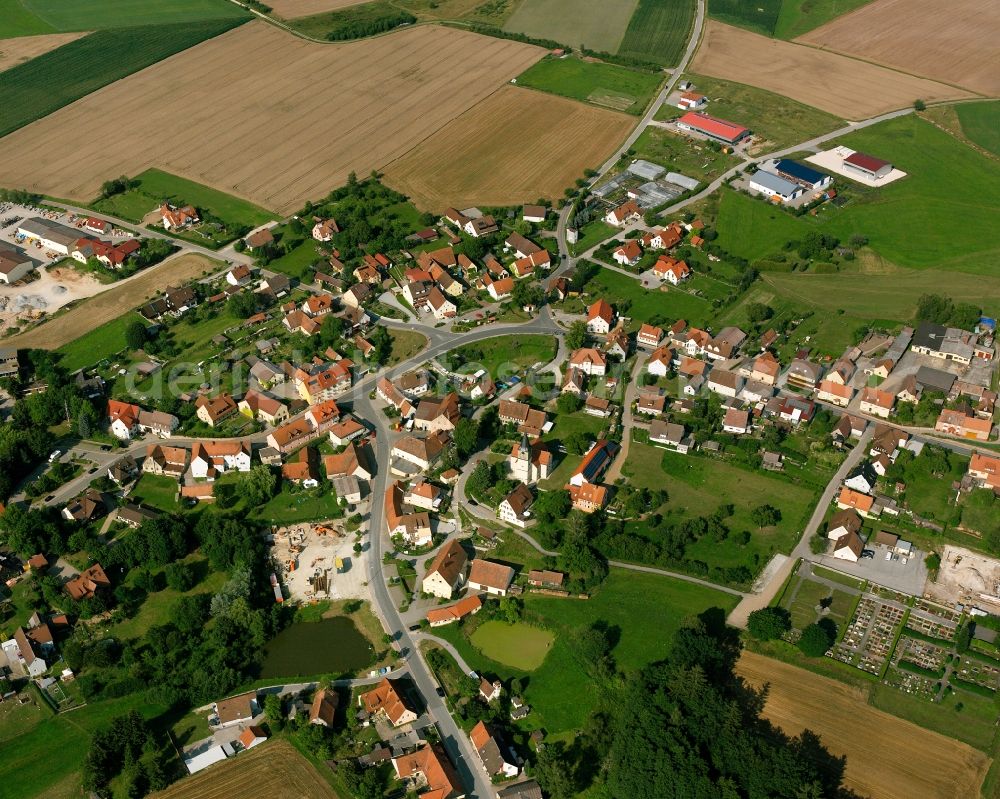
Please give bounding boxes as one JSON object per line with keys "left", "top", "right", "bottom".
{"left": 0, "top": 254, "right": 223, "bottom": 350}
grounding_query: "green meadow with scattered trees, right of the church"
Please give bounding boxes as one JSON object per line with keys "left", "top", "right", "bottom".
{"left": 622, "top": 441, "right": 815, "bottom": 573}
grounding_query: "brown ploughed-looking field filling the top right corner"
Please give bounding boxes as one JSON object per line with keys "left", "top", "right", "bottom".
{"left": 795, "top": 0, "right": 1000, "bottom": 96}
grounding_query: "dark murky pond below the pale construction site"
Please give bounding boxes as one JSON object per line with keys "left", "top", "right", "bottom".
{"left": 261, "top": 616, "right": 375, "bottom": 678}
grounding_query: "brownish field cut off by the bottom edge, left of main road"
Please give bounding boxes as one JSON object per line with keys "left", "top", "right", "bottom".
{"left": 150, "top": 741, "right": 337, "bottom": 799}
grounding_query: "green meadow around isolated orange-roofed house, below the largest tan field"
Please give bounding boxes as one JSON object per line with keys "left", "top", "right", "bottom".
{"left": 93, "top": 169, "right": 277, "bottom": 228}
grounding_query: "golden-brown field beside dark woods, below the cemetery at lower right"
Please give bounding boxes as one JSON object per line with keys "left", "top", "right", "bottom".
{"left": 736, "top": 651, "right": 989, "bottom": 799}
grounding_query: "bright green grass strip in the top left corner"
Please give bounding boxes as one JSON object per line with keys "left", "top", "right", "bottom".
{"left": 0, "top": 0, "right": 249, "bottom": 37}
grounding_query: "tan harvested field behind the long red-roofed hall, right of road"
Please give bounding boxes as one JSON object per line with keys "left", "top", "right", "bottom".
{"left": 691, "top": 20, "right": 972, "bottom": 122}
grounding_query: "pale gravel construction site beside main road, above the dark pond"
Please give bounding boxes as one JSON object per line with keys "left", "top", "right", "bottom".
{"left": 271, "top": 522, "right": 367, "bottom": 602}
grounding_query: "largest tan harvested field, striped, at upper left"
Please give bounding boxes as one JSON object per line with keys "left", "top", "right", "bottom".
{"left": 0, "top": 22, "right": 545, "bottom": 213}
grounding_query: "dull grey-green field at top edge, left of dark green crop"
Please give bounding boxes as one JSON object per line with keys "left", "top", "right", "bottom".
{"left": 503, "top": 0, "right": 638, "bottom": 53}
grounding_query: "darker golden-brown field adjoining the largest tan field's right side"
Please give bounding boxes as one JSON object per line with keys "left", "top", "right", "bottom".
{"left": 384, "top": 86, "right": 635, "bottom": 210}
